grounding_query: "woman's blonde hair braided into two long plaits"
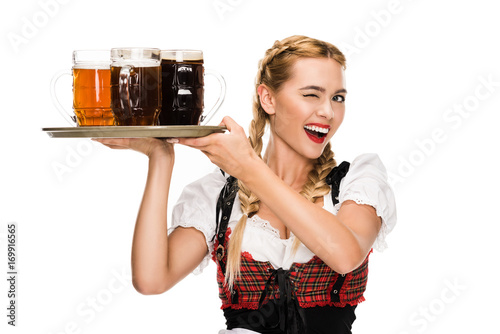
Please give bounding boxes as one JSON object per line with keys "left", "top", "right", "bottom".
{"left": 225, "top": 36, "right": 345, "bottom": 289}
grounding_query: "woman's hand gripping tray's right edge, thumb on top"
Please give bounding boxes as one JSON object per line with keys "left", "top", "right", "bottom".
{"left": 178, "top": 116, "right": 257, "bottom": 178}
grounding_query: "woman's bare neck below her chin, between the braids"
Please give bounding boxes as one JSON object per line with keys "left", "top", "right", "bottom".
{"left": 262, "top": 135, "right": 315, "bottom": 192}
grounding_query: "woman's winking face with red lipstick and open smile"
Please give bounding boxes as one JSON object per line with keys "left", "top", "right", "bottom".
{"left": 264, "top": 58, "right": 347, "bottom": 159}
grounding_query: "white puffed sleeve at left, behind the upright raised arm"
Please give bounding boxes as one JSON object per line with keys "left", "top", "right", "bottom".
{"left": 168, "top": 169, "right": 226, "bottom": 274}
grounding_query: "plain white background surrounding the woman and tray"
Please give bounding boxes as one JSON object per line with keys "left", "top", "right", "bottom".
{"left": 0, "top": 0, "right": 500, "bottom": 334}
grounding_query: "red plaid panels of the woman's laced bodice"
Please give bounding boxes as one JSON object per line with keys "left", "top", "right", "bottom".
{"left": 212, "top": 228, "right": 371, "bottom": 309}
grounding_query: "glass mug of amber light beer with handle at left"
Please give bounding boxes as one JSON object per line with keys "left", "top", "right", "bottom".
{"left": 51, "top": 50, "right": 115, "bottom": 126}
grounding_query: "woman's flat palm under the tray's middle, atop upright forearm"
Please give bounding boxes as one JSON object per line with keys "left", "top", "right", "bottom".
{"left": 92, "top": 138, "right": 174, "bottom": 158}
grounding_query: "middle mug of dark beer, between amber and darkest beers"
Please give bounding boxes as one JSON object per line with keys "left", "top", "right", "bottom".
{"left": 111, "top": 48, "right": 161, "bottom": 126}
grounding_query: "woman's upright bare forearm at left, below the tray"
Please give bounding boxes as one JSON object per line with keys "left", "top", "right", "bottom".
{"left": 132, "top": 154, "right": 174, "bottom": 294}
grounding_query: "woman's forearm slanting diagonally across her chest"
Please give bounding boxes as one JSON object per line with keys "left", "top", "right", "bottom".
{"left": 241, "top": 159, "right": 373, "bottom": 273}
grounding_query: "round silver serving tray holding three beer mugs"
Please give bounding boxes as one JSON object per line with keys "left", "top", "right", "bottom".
{"left": 42, "top": 125, "right": 226, "bottom": 138}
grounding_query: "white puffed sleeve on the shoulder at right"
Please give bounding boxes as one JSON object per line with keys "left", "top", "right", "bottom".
{"left": 336, "top": 153, "right": 397, "bottom": 251}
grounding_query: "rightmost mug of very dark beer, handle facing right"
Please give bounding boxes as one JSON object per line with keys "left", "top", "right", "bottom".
{"left": 159, "top": 50, "right": 226, "bottom": 125}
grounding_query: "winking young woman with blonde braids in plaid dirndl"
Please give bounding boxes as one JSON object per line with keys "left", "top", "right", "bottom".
{"left": 94, "top": 36, "right": 396, "bottom": 334}
